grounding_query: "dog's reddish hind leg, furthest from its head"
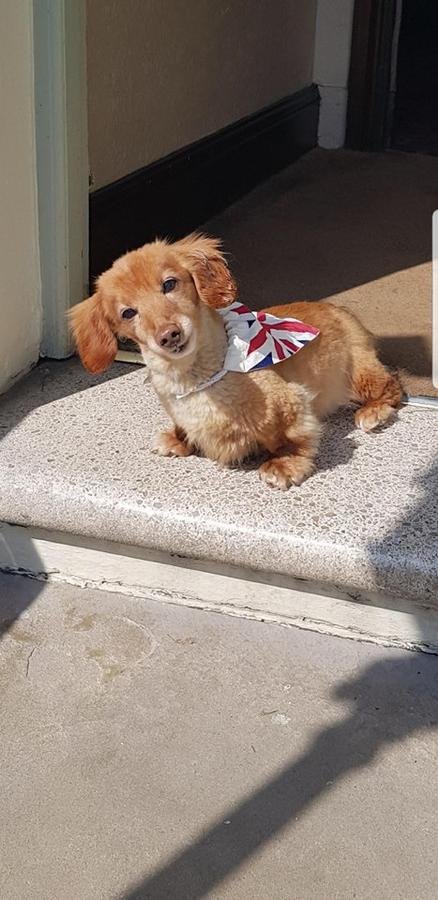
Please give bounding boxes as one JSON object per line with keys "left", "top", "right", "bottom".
{"left": 351, "top": 351, "right": 403, "bottom": 431}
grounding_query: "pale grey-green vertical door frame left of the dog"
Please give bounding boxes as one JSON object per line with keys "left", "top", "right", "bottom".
{"left": 33, "top": 0, "right": 88, "bottom": 359}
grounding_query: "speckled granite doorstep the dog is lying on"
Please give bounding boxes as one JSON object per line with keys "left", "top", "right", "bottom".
{"left": 0, "top": 360, "right": 438, "bottom": 605}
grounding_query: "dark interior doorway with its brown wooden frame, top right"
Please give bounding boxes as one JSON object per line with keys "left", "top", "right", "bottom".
{"left": 346, "top": 0, "right": 438, "bottom": 156}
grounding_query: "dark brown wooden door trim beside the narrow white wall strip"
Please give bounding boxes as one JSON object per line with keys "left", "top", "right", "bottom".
{"left": 346, "top": 0, "right": 397, "bottom": 150}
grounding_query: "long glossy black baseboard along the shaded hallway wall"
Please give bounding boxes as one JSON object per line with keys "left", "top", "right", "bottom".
{"left": 90, "top": 85, "right": 319, "bottom": 283}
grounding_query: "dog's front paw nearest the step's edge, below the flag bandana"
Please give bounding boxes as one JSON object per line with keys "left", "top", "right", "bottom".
{"left": 259, "top": 420, "right": 320, "bottom": 491}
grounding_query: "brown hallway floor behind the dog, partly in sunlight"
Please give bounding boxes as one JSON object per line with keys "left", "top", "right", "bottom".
{"left": 205, "top": 149, "right": 438, "bottom": 396}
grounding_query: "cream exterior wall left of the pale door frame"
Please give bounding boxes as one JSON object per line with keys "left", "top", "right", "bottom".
{"left": 0, "top": 0, "right": 42, "bottom": 391}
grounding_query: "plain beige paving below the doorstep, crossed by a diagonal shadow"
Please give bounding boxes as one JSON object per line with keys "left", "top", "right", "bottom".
{"left": 0, "top": 575, "right": 438, "bottom": 900}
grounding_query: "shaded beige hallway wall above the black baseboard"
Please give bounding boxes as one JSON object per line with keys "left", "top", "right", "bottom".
{"left": 87, "top": 0, "right": 316, "bottom": 188}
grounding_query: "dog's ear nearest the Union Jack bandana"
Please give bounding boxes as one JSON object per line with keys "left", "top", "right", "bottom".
{"left": 174, "top": 234, "right": 237, "bottom": 309}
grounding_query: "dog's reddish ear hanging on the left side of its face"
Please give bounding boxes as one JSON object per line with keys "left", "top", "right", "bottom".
{"left": 69, "top": 292, "right": 117, "bottom": 373}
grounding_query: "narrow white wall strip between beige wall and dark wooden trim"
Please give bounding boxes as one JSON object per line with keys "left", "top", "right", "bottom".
{"left": 313, "top": 0, "right": 354, "bottom": 149}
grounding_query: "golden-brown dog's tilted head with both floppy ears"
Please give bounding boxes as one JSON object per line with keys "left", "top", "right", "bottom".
{"left": 70, "top": 235, "right": 237, "bottom": 372}
